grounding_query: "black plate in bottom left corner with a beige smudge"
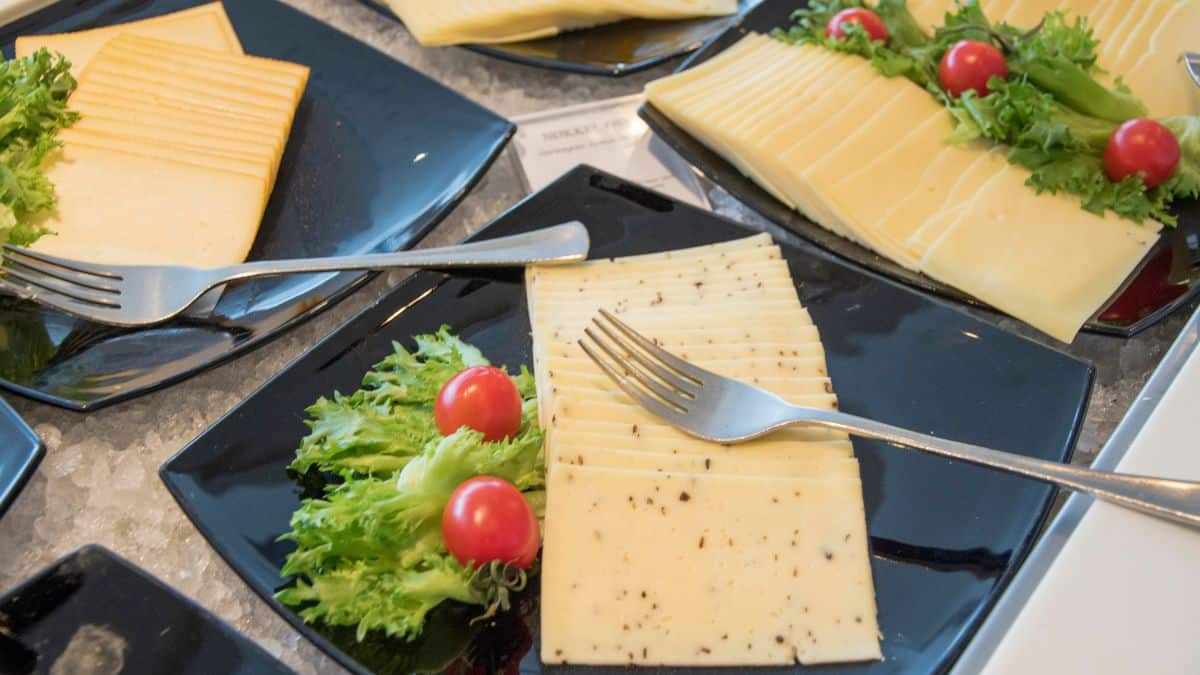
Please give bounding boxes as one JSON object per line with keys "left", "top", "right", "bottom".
{"left": 0, "top": 545, "right": 292, "bottom": 675}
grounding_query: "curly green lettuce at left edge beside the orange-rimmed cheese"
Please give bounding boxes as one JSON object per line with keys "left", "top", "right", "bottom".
{"left": 0, "top": 49, "right": 78, "bottom": 246}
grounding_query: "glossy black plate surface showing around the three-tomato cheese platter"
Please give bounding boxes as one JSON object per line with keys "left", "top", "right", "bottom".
{"left": 641, "top": 0, "right": 1200, "bottom": 336}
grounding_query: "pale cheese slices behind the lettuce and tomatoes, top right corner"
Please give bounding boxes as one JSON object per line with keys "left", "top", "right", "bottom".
{"left": 910, "top": 0, "right": 1200, "bottom": 118}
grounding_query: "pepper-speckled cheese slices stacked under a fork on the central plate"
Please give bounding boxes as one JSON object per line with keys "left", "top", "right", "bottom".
{"left": 527, "top": 235, "right": 880, "bottom": 665}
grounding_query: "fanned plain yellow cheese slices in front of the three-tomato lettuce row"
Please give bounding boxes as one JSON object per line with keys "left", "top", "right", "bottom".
{"left": 646, "top": 34, "right": 1160, "bottom": 341}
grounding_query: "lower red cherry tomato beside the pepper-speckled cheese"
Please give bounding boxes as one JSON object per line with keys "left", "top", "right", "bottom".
{"left": 442, "top": 476, "right": 541, "bottom": 569}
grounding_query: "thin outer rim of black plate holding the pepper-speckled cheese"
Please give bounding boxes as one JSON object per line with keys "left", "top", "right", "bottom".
{"left": 158, "top": 165, "right": 1096, "bottom": 675}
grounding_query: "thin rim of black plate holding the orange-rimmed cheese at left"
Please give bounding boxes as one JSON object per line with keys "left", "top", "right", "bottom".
{"left": 0, "top": 125, "right": 516, "bottom": 412}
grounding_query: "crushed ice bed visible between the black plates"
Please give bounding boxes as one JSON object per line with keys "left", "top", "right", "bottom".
{"left": 0, "top": 0, "right": 1194, "bottom": 674}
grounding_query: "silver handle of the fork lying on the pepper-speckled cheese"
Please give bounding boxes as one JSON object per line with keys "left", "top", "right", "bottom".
{"left": 785, "top": 407, "right": 1200, "bottom": 527}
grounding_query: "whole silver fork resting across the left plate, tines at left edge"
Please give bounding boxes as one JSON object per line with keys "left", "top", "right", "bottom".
{"left": 0, "top": 222, "right": 590, "bottom": 327}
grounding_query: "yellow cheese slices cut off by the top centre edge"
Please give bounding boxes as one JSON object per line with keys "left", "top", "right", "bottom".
{"left": 386, "top": 0, "right": 738, "bottom": 47}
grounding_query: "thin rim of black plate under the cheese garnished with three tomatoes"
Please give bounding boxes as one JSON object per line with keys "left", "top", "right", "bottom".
{"left": 637, "top": 7, "right": 1200, "bottom": 338}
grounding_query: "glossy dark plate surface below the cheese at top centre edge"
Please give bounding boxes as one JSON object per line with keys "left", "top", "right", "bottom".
{"left": 361, "top": 0, "right": 762, "bottom": 77}
